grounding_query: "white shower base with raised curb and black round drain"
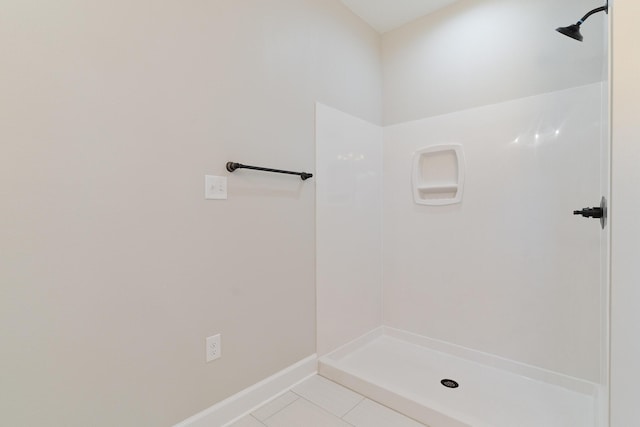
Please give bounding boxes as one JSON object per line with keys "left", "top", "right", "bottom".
{"left": 318, "top": 327, "right": 599, "bottom": 427}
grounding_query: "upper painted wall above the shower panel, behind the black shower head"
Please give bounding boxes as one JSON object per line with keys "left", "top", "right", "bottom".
{"left": 382, "top": 0, "right": 606, "bottom": 124}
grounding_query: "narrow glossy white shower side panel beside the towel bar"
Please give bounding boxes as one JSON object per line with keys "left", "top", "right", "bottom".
{"left": 316, "top": 104, "right": 382, "bottom": 355}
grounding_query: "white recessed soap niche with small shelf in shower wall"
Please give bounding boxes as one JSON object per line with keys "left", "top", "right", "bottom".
{"left": 412, "top": 144, "right": 465, "bottom": 206}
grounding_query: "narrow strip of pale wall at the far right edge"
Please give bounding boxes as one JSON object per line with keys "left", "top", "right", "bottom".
{"left": 611, "top": 0, "right": 640, "bottom": 427}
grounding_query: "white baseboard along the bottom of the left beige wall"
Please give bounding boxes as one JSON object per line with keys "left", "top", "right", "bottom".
{"left": 174, "top": 354, "right": 318, "bottom": 427}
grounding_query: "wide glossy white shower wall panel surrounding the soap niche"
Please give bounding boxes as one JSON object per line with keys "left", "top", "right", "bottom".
{"left": 383, "top": 84, "right": 603, "bottom": 382}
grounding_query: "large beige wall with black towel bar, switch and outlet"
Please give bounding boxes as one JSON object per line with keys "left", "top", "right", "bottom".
{"left": 0, "top": 0, "right": 381, "bottom": 427}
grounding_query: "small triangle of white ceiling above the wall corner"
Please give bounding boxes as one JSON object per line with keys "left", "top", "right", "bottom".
{"left": 342, "top": 0, "right": 458, "bottom": 33}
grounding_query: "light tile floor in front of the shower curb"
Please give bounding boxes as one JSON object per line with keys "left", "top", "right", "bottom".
{"left": 229, "top": 375, "right": 424, "bottom": 427}
